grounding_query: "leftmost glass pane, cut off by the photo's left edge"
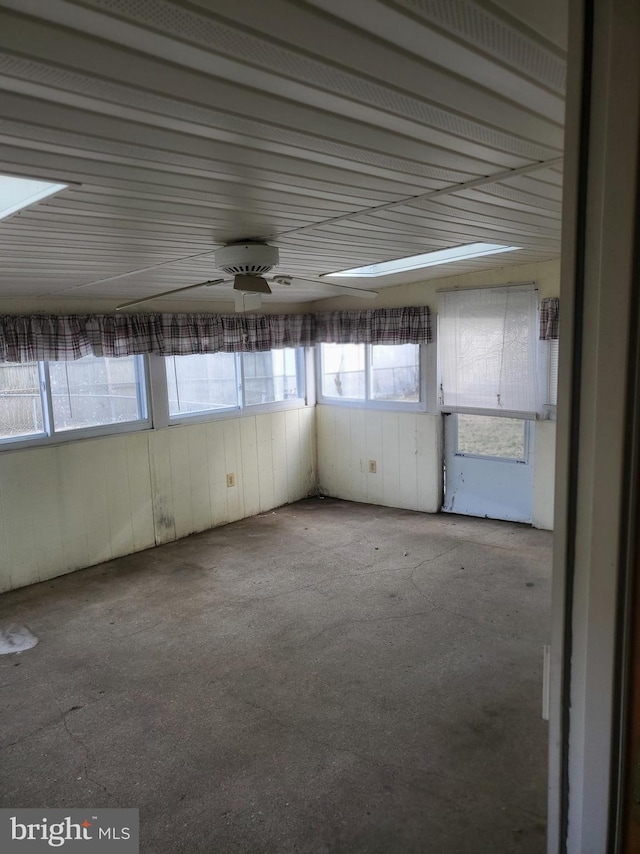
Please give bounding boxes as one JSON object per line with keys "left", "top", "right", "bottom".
{"left": 0, "top": 364, "right": 44, "bottom": 439}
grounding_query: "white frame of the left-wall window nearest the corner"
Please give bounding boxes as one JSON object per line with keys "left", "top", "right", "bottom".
{"left": 161, "top": 347, "right": 310, "bottom": 428}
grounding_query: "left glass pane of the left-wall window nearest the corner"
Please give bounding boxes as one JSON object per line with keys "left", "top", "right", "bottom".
{"left": 165, "top": 353, "right": 238, "bottom": 415}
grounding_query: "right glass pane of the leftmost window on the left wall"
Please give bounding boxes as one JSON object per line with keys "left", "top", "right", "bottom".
{"left": 49, "top": 356, "right": 145, "bottom": 431}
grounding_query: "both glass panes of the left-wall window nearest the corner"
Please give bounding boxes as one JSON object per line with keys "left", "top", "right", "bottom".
{"left": 165, "top": 348, "right": 304, "bottom": 419}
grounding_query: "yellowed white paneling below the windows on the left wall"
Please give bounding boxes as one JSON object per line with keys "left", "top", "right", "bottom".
{"left": 0, "top": 408, "right": 315, "bottom": 592}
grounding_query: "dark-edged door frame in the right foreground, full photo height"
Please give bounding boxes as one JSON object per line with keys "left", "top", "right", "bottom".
{"left": 547, "top": 0, "right": 640, "bottom": 854}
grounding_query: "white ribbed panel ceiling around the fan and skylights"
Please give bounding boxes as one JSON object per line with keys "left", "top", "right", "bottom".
{"left": 0, "top": 0, "right": 566, "bottom": 311}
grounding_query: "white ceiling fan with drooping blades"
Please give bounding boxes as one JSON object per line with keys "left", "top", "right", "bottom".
{"left": 116, "top": 240, "right": 378, "bottom": 311}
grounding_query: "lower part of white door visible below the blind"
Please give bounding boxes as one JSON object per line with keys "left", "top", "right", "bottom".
{"left": 442, "top": 414, "right": 535, "bottom": 522}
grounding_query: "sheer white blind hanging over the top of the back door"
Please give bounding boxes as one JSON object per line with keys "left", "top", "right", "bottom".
{"left": 438, "top": 285, "right": 539, "bottom": 417}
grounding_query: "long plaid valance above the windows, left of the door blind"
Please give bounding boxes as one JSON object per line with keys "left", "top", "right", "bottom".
{"left": 0, "top": 307, "right": 431, "bottom": 362}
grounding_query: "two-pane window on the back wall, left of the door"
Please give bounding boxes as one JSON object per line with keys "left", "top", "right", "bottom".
{"left": 320, "top": 344, "right": 420, "bottom": 406}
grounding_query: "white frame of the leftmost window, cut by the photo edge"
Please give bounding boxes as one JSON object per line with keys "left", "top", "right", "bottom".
{"left": 0, "top": 355, "right": 153, "bottom": 453}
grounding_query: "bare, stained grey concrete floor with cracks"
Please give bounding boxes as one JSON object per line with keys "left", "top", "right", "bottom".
{"left": 0, "top": 499, "right": 551, "bottom": 854}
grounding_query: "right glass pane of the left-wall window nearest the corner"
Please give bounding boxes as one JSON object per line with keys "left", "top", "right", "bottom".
{"left": 242, "top": 348, "right": 301, "bottom": 406}
